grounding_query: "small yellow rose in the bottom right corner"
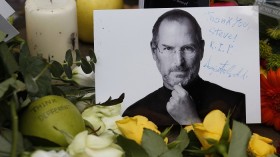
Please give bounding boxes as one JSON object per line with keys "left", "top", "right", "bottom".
{"left": 248, "top": 133, "right": 276, "bottom": 157}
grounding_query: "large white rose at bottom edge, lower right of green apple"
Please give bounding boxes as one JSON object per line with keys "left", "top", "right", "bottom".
{"left": 68, "top": 131, "right": 124, "bottom": 157}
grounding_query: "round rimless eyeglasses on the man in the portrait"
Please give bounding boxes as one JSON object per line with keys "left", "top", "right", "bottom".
{"left": 157, "top": 45, "right": 197, "bottom": 55}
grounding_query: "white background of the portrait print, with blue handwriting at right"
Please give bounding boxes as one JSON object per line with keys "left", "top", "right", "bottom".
{"left": 94, "top": 6, "right": 260, "bottom": 123}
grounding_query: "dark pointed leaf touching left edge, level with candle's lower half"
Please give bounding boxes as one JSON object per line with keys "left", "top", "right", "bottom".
{"left": 0, "top": 42, "right": 19, "bottom": 75}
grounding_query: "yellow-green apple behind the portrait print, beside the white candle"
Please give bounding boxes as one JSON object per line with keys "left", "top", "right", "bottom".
{"left": 77, "top": 0, "right": 123, "bottom": 43}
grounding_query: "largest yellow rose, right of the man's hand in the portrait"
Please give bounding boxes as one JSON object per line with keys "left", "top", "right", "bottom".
{"left": 185, "top": 110, "right": 232, "bottom": 149}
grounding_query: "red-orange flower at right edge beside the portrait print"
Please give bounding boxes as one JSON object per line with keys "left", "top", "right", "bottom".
{"left": 261, "top": 68, "right": 280, "bottom": 130}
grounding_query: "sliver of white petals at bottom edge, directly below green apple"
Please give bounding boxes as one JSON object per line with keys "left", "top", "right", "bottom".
{"left": 31, "top": 150, "right": 70, "bottom": 157}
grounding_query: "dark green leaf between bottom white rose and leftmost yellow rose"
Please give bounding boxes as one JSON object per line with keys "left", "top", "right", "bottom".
{"left": 117, "top": 135, "right": 149, "bottom": 157}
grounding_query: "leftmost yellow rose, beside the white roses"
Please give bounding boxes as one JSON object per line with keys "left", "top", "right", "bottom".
{"left": 116, "top": 115, "right": 160, "bottom": 144}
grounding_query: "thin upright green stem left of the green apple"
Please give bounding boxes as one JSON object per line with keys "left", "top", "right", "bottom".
{"left": 9, "top": 93, "right": 18, "bottom": 157}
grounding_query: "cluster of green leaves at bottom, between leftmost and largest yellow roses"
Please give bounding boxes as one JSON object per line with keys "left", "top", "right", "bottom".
{"left": 117, "top": 128, "right": 189, "bottom": 157}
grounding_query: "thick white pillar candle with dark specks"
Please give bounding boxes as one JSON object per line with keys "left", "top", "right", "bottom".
{"left": 25, "top": 0, "right": 78, "bottom": 62}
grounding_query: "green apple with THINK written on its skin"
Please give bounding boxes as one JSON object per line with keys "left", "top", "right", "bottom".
{"left": 19, "top": 95, "right": 85, "bottom": 146}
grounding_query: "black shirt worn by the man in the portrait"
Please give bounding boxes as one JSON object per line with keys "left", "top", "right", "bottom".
{"left": 123, "top": 77, "right": 246, "bottom": 126}
